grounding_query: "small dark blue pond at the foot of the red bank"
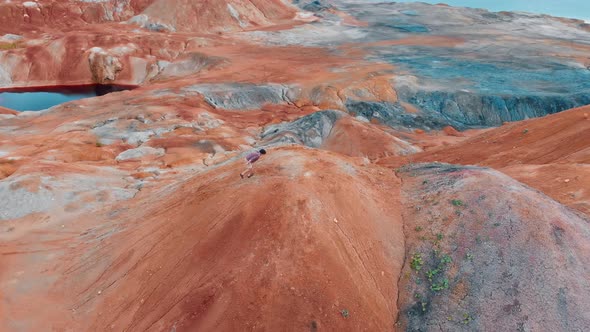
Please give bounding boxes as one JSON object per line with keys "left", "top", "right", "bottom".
{"left": 0, "top": 85, "right": 134, "bottom": 111}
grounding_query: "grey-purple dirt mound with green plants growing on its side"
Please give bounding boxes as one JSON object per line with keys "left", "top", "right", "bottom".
{"left": 399, "top": 164, "right": 590, "bottom": 331}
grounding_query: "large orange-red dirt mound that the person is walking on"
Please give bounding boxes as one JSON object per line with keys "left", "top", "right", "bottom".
{"left": 0, "top": 148, "right": 404, "bottom": 331}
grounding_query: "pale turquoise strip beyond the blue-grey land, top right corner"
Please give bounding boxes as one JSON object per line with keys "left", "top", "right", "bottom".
{"left": 391, "top": 0, "right": 590, "bottom": 21}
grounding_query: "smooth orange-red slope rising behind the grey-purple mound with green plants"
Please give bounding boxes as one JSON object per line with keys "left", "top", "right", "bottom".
{"left": 388, "top": 106, "right": 590, "bottom": 213}
